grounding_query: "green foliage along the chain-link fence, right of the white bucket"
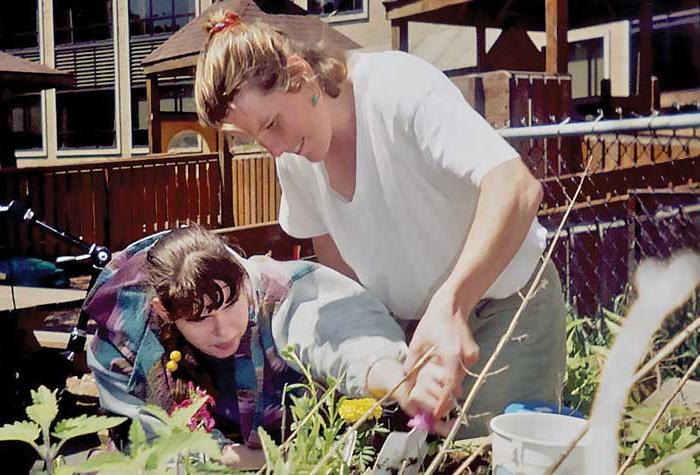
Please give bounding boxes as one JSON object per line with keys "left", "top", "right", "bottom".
{"left": 563, "top": 292, "right": 700, "bottom": 475}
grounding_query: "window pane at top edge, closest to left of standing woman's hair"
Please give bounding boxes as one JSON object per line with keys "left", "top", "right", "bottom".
{"left": 129, "top": 0, "right": 194, "bottom": 36}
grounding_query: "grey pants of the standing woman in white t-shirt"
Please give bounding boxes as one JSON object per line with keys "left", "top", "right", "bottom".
{"left": 458, "top": 262, "right": 566, "bottom": 439}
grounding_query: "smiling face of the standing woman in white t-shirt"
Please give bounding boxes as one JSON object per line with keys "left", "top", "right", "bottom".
{"left": 224, "top": 82, "right": 332, "bottom": 162}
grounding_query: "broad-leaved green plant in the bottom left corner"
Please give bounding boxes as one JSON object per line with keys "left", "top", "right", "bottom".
{"left": 0, "top": 386, "right": 126, "bottom": 475}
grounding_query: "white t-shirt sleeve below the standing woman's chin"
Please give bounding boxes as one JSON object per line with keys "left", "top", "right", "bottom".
{"left": 276, "top": 156, "right": 328, "bottom": 239}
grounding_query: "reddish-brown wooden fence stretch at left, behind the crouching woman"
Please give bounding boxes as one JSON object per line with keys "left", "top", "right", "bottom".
{"left": 0, "top": 154, "right": 226, "bottom": 256}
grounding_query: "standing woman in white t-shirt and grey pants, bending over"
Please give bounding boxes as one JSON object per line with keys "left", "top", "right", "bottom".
{"left": 195, "top": 12, "right": 565, "bottom": 435}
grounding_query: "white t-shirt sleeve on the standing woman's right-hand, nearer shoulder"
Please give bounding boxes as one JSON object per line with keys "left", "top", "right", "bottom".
{"left": 413, "top": 80, "right": 520, "bottom": 186}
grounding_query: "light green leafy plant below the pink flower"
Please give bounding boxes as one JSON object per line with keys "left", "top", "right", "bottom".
{"left": 70, "top": 396, "right": 227, "bottom": 475}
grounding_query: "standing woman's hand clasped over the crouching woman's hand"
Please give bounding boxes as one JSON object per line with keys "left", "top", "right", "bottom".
{"left": 404, "top": 291, "right": 479, "bottom": 419}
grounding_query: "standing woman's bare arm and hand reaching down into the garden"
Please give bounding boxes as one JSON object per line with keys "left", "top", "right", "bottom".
{"left": 407, "top": 160, "right": 542, "bottom": 415}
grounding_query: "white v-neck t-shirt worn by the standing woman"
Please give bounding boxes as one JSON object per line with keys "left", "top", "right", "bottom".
{"left": 276, "top": 51, "right": 546, "bottom": 319}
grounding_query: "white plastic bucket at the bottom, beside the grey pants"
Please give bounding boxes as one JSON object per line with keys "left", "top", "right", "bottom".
{"left": 491, "top": 412, "right": 586, "bottom": 475}
